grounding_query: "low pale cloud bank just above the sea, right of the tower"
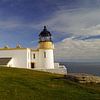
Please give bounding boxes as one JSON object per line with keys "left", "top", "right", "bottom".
{"left": 55, "top": 38, "right": 100, "bottom": 62}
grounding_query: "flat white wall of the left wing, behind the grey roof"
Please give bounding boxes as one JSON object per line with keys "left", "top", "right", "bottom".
{"left": 0, "top": 49, "right": 28, "bottom": 68}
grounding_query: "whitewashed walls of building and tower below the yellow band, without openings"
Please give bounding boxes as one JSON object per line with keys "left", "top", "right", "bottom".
{"left": 0, "top": 48, "right": 54, "bottom": 69}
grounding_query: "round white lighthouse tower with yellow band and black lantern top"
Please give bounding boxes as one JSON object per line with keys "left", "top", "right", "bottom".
{"left": 39, "top": 26, "right": 54, "bottom": 69}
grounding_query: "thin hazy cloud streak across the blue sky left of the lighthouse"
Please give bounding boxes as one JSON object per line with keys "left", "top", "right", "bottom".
{"left": 0, "top": 17, "right": 36, "bottom": 31}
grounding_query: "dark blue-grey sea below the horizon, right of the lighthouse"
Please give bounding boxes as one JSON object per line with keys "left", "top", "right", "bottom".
{"left": 60, "top": 62, "right": 100, "bottom": 76}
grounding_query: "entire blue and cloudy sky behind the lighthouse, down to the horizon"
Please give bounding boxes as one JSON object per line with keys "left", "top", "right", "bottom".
{"left": 0, "top": 0, "right": 100, "bottom": 62}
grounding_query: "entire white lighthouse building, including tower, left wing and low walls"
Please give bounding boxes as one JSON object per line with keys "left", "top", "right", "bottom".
{"left": 0, "top": 26, "right": 65, "bottom": 73}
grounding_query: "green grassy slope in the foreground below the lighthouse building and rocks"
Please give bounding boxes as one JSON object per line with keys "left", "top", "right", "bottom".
{"left": 0, "top": 67, "right": 100, "bottom": 100}
